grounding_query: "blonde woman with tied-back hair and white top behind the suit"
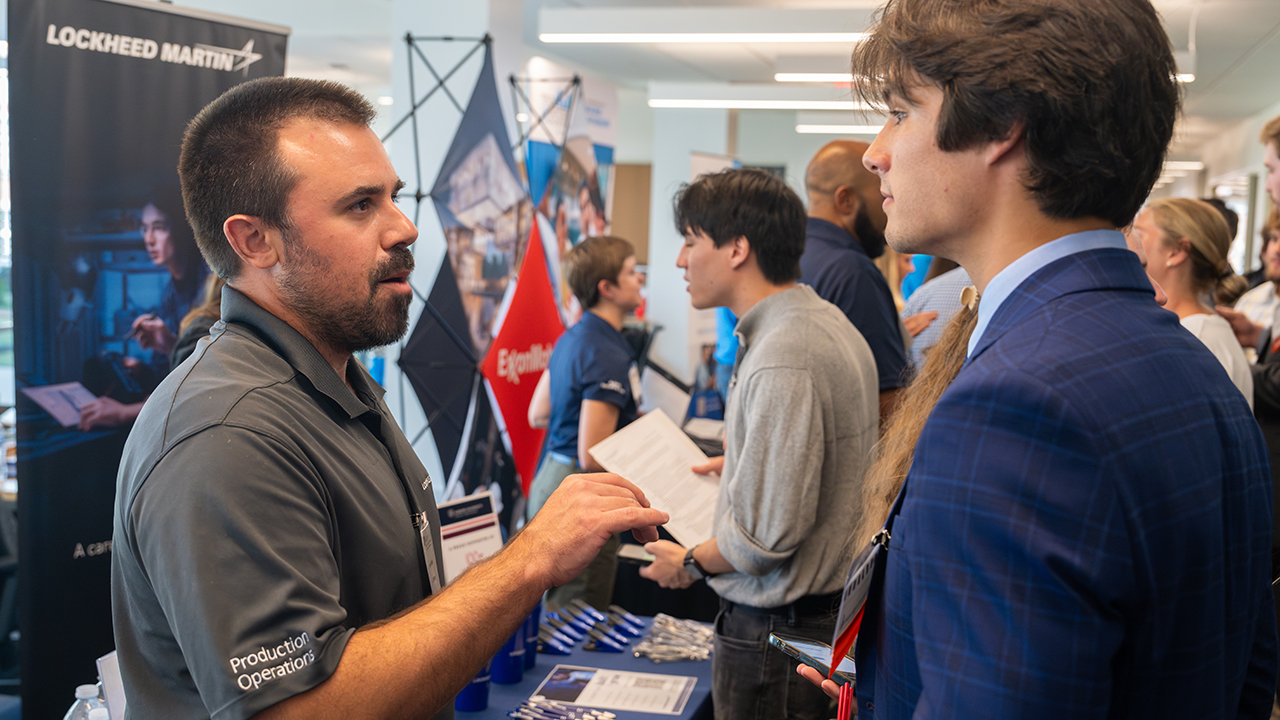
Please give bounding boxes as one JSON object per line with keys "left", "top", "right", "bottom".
{"left": 1133, "top": 197, "right": 1253, "bottom": 407}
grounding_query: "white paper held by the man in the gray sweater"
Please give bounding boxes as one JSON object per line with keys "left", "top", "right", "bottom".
{"left": 588, "top": 410, "right": 719, "bottom": 547}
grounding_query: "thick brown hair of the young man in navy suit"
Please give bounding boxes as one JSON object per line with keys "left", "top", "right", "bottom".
{"left": 852, "top": 0, "right": 1181, "bottom": 227}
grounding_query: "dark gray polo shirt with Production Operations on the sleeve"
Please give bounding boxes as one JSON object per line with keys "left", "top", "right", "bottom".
{"left": 111, "top": 287, "right": 452, "bottom": 720}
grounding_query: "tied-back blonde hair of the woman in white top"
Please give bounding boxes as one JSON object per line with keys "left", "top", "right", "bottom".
{"left": 1147, "top": 197, "right": 1249, "bottom": 305}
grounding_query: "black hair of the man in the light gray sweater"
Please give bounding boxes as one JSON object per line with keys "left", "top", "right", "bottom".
{"left": 675, "top": 168, "right": 806, "bottom": 284}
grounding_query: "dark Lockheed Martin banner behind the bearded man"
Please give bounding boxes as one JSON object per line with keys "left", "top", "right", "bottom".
{"left": 8, "top": 0, "right": 288, "bottom": 717}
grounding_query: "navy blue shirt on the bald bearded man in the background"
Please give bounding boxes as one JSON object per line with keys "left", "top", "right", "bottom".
{"left": 800, "top": 218, "right": 909, "bottom": 391}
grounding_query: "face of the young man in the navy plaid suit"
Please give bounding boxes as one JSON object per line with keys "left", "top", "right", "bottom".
{"left": 863, "top": 85, "right": 991, "bottom": 258}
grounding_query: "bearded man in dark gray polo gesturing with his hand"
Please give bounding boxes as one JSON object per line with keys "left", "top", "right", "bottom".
{"left": 111, "top": 78, "right": 667, "bottom": 720}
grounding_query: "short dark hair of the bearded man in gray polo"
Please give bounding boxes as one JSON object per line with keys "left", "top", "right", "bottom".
{"left": 178, "top": 77, "right": 376, "bottom": 279}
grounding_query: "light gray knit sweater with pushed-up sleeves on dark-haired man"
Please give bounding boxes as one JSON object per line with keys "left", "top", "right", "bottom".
{"left": 709, "top": 284, "right": 879, "bottom": 607}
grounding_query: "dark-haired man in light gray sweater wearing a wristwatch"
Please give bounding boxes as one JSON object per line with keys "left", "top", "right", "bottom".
{"left": 641, "top": 169, "right": 879, "bottom": 720}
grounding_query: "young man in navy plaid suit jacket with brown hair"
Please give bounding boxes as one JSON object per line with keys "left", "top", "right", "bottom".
{"left": 808, "top": 0, "right": 1276, "bottom": 720}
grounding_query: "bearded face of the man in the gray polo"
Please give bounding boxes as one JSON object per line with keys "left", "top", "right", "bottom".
{"left": 276, "top": 119, "right": 417, "bottom": 352}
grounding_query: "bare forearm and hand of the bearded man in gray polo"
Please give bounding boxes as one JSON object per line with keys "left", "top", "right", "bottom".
{"left": 256, "top": 473, "right": 671, "bottom": 720}
